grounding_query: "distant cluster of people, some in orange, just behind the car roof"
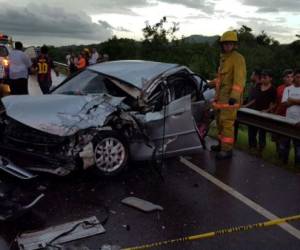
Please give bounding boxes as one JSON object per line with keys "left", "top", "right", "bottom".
{"left": 66, "top": 48, "right": 109, "bottom": 74}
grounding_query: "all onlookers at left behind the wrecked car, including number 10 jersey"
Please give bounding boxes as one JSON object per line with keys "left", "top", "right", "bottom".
{"left": 0, "top": 41, "right": 109, "bottom": 97}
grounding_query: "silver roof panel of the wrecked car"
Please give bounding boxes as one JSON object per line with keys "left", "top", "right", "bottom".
{"left": 88, "top": 60, "right": 179, "bottom": 89}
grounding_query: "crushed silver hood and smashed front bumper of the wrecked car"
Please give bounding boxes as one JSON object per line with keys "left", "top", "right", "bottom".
{"left": 0, "top": 95, "right": 127, "bottom": 177}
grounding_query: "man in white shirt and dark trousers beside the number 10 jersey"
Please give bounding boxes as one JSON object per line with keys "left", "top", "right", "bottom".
{"left": 9, "top": 42, "right": 32, "bottom": 95}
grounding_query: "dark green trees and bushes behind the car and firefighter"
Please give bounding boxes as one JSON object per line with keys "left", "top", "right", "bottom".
{"left": 50, "top": 17, "right": 300, "bottom": 84}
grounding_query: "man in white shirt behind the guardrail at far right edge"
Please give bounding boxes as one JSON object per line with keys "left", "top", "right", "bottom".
{"left": 282, "top": 69, "right": 300, "bottom": 166}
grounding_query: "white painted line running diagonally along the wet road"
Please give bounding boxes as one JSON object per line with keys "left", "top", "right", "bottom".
{"left": 180, "top": 157, "right": 300, "bottom": 239}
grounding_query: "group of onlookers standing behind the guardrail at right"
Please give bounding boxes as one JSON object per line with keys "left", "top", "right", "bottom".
{"left": 243, "top": 69, "right": 300, "bottom": 167}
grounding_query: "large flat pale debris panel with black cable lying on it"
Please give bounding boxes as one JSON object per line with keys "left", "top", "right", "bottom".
{"left": 17, "top": 216, "right": 105, "bottom": 250}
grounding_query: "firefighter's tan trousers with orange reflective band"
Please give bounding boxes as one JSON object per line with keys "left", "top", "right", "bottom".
{"left": 216, "top": 108, "right": 237, "bottom": 151}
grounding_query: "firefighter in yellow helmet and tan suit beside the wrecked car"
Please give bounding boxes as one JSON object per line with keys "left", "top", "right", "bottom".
{"left": 211, "top": 31, "right": 246, "bottom": 160}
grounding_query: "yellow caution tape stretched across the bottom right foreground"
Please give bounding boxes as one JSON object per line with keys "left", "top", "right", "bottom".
{"left": 121, "top": 215, "right": 300, "bottom": 250}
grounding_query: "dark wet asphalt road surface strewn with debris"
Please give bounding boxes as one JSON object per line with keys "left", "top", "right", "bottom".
{"left": 1, "top": 143, "right": 300, "bottom": 250}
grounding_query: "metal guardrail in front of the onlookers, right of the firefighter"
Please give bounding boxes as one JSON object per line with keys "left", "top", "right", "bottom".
{"left": 237, "top": 108, "right": 300, "bottom": 140}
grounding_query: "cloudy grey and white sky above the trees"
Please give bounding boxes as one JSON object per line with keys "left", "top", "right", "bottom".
{"left": 0, "top": 0, "right": 300, "bottom": 45}
